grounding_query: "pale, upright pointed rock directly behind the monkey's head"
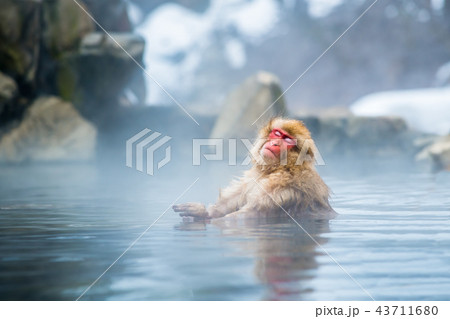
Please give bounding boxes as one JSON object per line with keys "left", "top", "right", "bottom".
{"left": 211, "top": 72, "right": 286, "bottom": 139}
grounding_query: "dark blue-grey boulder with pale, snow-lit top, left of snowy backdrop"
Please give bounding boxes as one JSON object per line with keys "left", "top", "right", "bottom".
{"left": 57, "top": 32, "right": 145, "bottom": 121}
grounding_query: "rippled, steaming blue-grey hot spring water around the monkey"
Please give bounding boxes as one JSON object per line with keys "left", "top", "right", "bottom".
{"left": 0, "top": 165, "right": 450, "bottom": 300}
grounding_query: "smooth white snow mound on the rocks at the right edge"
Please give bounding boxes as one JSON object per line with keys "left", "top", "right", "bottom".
{"left": 350, "top": 87, "right": 450, "bottom": 135}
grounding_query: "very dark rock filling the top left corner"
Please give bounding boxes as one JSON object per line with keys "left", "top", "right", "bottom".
{"left": 0, "top": 0, "right": 41, "bottom": 89}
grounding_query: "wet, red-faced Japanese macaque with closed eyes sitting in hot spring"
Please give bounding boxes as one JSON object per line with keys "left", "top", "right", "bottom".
{"left": 173, "top": 118, "right": 336, "bottom": 219}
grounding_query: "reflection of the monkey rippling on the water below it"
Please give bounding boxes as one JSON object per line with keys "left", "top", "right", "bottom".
{"left": 176, "top": 216, "right": 329, "bottom": 300}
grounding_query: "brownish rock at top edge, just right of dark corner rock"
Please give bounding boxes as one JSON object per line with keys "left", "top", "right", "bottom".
{"left": 43, "top": 0, "right": 95, "bottom": 58}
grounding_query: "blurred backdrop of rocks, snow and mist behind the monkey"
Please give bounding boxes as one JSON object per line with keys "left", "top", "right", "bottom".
{"left": 0, "top": 0, "right": 450, "bottom": 170}
